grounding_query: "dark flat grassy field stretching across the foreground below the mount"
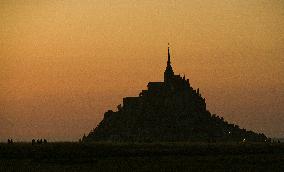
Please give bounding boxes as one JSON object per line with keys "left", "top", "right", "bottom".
{"left": 0, "top": 143, "right": 284, "bottom": 172}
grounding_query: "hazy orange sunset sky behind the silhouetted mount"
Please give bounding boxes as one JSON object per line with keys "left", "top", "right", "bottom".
{"left": 0, "top": 0, "right": 284, "bottom": 141}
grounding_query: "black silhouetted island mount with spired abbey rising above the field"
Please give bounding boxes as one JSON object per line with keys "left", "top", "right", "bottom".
{"left": 83, "top": 47, "right": 268, "bottom": 142}
